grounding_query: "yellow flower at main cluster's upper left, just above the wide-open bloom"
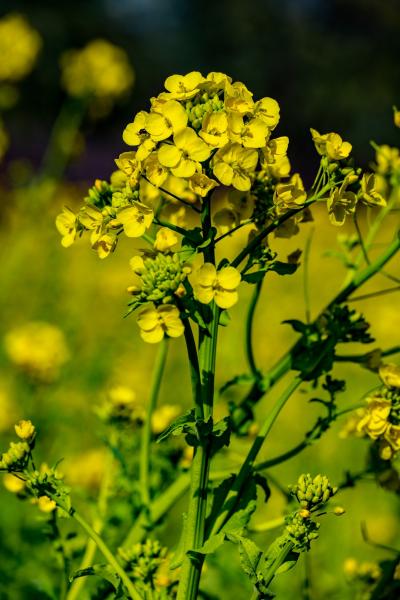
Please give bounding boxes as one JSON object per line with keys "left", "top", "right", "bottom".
{"left": 146, "top": 99, "right": 188, "bottom": 142}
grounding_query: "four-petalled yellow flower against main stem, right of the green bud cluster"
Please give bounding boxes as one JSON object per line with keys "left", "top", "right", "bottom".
{"left": 192, "top": 263, "right": 241, "bottom": 308}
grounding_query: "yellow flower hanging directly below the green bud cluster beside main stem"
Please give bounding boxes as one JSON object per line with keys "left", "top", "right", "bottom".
{"left": 137, "top": 304, "right": 184, "bottom": 344}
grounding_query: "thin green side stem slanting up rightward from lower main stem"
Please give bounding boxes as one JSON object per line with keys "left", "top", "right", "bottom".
{"left": 212, "top": 377, "right": 302, "bottom": 534}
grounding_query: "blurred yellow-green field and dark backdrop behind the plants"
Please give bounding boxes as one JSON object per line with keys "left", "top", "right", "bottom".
{"left": 0, "top": 0, "right": 400, "bottom": 600}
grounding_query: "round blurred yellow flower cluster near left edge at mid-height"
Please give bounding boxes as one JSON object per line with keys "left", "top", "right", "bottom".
{"left": 5, "top": 321, "right": 69, "bottom": 383}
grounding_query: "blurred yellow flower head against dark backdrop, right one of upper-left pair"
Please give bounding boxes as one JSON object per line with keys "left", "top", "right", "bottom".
{"left": 61, "top": 39, "right": 134, "bottom": 100}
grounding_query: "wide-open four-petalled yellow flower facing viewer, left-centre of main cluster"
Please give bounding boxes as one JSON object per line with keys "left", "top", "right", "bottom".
{"left": 158, "top": 127, "right": 210, "bottom": 177}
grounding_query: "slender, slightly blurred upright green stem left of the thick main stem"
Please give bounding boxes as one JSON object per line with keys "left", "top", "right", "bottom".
{"left": 140, "top": 337, "right": 168, "bottom": 508}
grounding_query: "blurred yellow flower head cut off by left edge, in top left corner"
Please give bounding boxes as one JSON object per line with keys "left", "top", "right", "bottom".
{"left": 0, "top": 14, "right": 42, "bottom": 81}
